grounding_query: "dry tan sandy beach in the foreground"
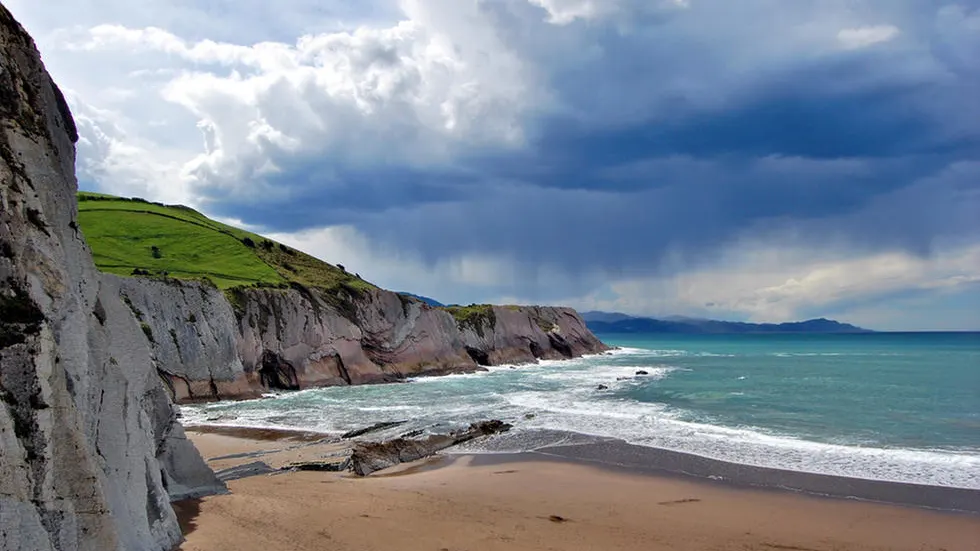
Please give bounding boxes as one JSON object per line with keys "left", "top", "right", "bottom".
{"left": 176, "top": 430, "right": 980, "bottom": 551}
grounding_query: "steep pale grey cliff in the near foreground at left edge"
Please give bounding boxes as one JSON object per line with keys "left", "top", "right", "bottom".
{"left": 0, "top": 6, "right": 224, "bottom": 551}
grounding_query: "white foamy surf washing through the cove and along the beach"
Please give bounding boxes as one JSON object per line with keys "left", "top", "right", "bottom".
{"left": 182, "top": 349, "right": 980, "bottom": 489}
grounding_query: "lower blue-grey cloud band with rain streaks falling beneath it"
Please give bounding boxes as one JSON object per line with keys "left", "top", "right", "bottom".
{"left": 359, "top": 163, "right": 980, "bottom": 275}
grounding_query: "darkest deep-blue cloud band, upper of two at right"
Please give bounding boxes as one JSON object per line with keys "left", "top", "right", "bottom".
{"left": 544, "top": 76, "right": 978, "bottom": 164}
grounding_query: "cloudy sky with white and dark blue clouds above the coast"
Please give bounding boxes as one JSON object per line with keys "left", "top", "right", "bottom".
{"left": 4, "top": 0, "right": 980, "bottom": 330}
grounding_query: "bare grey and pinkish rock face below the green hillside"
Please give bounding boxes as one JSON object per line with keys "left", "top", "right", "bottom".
{"left": 115, "top": 275, "right": 606, "bottom": 401}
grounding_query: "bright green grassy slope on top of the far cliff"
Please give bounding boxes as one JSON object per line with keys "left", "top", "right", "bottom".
{"left": 78, "top": 192, "right": 374, "bottom": 290}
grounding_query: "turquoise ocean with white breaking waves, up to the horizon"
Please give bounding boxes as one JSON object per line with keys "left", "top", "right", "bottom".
{"left": 181, "top": 333, "right": 980, "bottom": 489}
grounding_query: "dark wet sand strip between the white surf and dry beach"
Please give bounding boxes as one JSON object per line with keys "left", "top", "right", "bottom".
{"left": 185, "top": 425, "right": 980, "bottom": 515}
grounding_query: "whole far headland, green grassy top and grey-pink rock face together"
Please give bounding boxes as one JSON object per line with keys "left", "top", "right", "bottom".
{"left": 72, "top": 192, "right": 605, "bottom": 401}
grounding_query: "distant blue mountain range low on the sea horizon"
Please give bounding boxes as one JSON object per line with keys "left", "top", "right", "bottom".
{"left": 582, "top": 311, "right": 872, "bottom": 334}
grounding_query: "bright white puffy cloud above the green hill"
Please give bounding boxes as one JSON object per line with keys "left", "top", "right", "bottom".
{"left": 53, "top": 2, "right": 536, "bottom": 202}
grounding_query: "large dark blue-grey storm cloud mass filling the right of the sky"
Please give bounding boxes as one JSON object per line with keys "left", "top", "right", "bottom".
{"left": 201, "top": 3, "right": 980, "bottom": 280}
